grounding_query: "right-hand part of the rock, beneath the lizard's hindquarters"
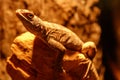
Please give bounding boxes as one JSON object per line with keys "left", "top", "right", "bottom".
{"left": 63, "top": 52, "right": 99, "bottom": 80}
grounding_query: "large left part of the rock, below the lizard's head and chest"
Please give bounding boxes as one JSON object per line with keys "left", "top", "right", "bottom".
{"left": 7, "top": 32, "right": 60, "bottom": 80}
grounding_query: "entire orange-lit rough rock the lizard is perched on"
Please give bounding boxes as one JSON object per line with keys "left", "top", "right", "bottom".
{"left": 7, "top": 32, "right": 98, "bottom": 80}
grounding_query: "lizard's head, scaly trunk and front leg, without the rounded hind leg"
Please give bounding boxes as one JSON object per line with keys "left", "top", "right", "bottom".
{"left": 16, "top": 9, "right": 96, "bottom": 71}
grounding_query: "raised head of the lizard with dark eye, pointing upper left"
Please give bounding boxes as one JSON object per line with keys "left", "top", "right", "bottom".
{"left": 16, "top": 9, "right": 42, "bottom": 35}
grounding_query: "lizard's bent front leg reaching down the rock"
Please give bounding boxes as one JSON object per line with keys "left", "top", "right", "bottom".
{"left": 48, "top": 38, "right": 66, "bottom": 72}
